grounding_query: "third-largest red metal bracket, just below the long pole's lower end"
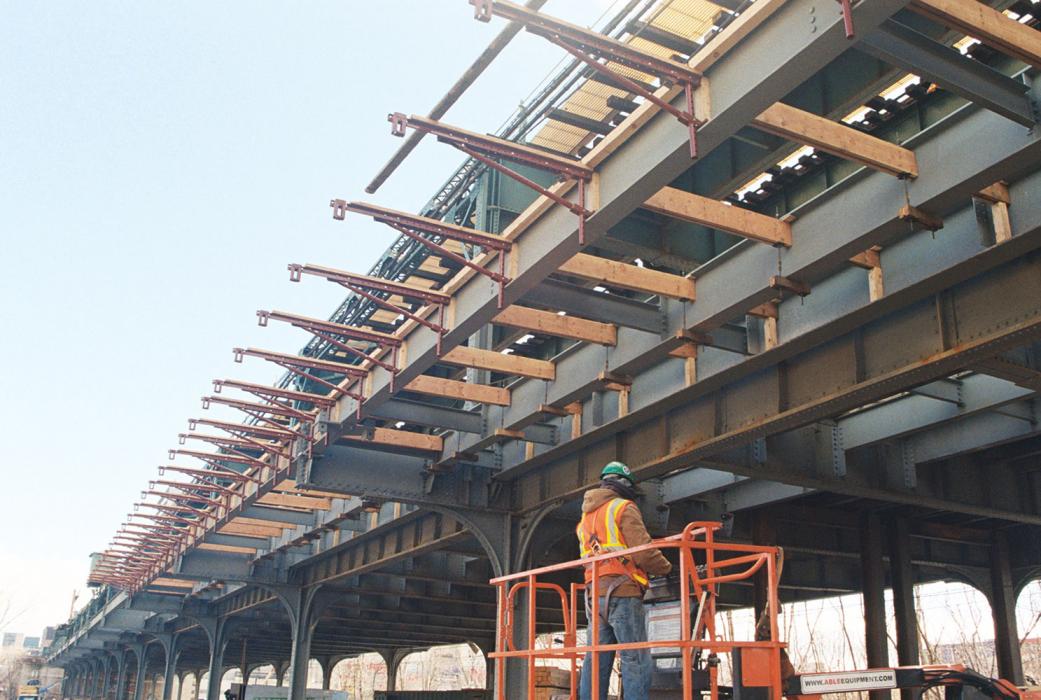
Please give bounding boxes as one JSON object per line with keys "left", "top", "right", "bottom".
{"left": 329, "top": 199, "right": 513, "bottom": 308}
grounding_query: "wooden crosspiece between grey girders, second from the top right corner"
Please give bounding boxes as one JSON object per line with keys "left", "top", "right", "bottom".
{"left": 752, "top": 102, "right": 916, "bottom": 177}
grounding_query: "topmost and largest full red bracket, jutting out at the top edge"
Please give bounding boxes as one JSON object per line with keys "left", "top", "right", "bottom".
{"left": 469, "top": 0, "right": 707, "bottom": 158}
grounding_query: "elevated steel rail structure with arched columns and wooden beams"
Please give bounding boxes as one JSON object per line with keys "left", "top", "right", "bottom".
{"left": 48, "top": 0, "right": 1041, "bottom": 700}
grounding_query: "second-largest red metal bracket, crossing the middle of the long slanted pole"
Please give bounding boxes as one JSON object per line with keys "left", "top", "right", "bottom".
{"left": 387, "top": 111, "right": 593, "bottom": 245}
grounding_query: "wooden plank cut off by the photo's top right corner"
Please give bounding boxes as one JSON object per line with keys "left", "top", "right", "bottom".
{"left": 911, "top": 0, "right": 1041, "bottom": 68}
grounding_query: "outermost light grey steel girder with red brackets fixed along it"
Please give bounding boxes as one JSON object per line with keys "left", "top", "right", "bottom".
{"left": 318, "top": 0, "right": 907, "bottom": 431}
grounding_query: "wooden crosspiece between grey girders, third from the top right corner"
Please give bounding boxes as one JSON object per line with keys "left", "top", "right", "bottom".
{"left": 643, "top": 188, "right": 791, "bottom": 246}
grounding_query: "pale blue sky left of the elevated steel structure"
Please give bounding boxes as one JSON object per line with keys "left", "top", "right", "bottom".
{"left": 0, "top": 0, "right": 612, "bottom": 633}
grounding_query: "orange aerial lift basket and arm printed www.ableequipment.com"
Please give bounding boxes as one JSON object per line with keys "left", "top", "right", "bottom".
{"left": 490, "top": 522, "right": 1041, "bottom": 700}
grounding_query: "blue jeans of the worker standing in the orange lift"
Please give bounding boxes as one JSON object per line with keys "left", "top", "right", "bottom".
{"left": 579, "top": 596, "right": 654, "bottom": 700}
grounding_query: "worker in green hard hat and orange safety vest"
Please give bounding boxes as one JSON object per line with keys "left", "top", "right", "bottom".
{"left": 576, "top": 461, "right": 672, "bottom": 700}
